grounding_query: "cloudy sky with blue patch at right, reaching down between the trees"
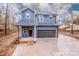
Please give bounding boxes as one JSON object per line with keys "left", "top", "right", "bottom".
{"left": 0, "top": 3, "right": 79, "bottom": 23}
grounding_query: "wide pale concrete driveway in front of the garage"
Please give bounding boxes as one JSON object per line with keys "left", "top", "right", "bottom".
{"left": 12, "top": 34, "right": 79, "bottom": 56}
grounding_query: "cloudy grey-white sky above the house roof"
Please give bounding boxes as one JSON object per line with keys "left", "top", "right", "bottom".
{"left": 16, "top": 3, "right": 79, "bottom": 18}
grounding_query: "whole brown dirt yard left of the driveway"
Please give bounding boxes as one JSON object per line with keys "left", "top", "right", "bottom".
{"left": 0, "top": 33, "right": 17, "bottom": 56}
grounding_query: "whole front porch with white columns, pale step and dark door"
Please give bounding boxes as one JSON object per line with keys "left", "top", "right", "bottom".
{"left": 18, "top": 26, "right": 37, "bottom": 42}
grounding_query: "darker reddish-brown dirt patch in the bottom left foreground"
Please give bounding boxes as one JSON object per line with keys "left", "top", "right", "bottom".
{"left": 0, "top": 43, "right": 17, "bottom": 56}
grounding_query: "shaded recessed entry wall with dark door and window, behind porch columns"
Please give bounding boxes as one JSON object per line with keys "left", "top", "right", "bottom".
{"left": 21, "top": 26, "right": 34, "bottom": 38}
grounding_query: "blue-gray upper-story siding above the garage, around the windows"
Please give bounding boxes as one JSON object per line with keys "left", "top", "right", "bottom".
{"left": 36, "top": 15, "right": 57, "bottom": 25}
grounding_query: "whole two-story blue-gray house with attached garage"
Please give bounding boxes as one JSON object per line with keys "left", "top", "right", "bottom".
{"left": 16, "top": 8, "right": 59, "bottom": 38}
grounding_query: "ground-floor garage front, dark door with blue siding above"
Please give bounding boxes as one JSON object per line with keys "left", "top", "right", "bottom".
{"left": 37, "top": 27, "right": 58, "bottom": 38}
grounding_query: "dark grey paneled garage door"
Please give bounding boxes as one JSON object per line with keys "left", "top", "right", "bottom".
{"left": 37, "top": 30, "right": 56, "bottom": 38}
